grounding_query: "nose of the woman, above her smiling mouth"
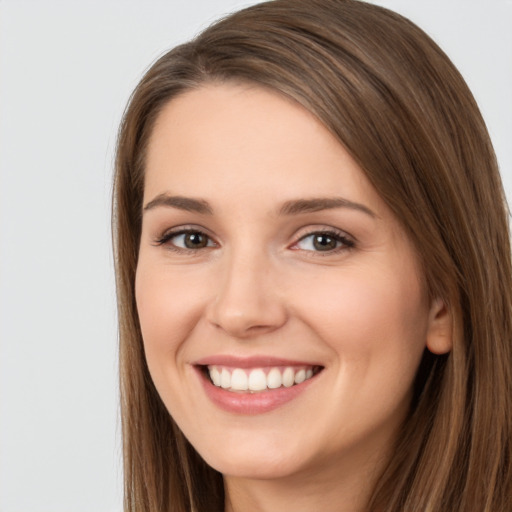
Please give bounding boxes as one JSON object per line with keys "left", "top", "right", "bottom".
{"left": 207, "top": 249, "right": 287, "bottom": 339}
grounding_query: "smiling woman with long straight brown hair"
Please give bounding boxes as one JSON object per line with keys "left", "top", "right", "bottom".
{"left": 114, "top": 0, "right": 512, "bottom": 512}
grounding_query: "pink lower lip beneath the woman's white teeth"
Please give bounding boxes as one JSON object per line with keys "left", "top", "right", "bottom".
{"left": 196, "top": 368, "right": 317, "bottom": 415}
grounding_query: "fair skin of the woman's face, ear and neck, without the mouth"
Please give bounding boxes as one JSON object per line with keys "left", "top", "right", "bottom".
{"left": 136, "top": 84, "right": 451, "bottom": 512}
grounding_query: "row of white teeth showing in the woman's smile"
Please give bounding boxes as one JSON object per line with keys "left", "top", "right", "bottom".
{"left": 208, "top": 365, "right": 314, "bottom": 392}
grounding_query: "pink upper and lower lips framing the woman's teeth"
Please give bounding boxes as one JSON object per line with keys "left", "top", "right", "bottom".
{"left": 194, "top": 355, "right": 318, "bottom": 415}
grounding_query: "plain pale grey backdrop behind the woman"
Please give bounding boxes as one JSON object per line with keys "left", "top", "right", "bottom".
{"left": 0, "top": 0, "right": 512, "bottom": 512}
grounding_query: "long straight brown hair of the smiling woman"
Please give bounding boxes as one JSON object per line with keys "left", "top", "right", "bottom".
{"left": 114, "top": 0, "right": 512, "bottom": 512}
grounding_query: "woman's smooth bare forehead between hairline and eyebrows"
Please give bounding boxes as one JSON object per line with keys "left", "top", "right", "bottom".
{"left": 145, "top": 84, "right": 383, "bottom": 218}
